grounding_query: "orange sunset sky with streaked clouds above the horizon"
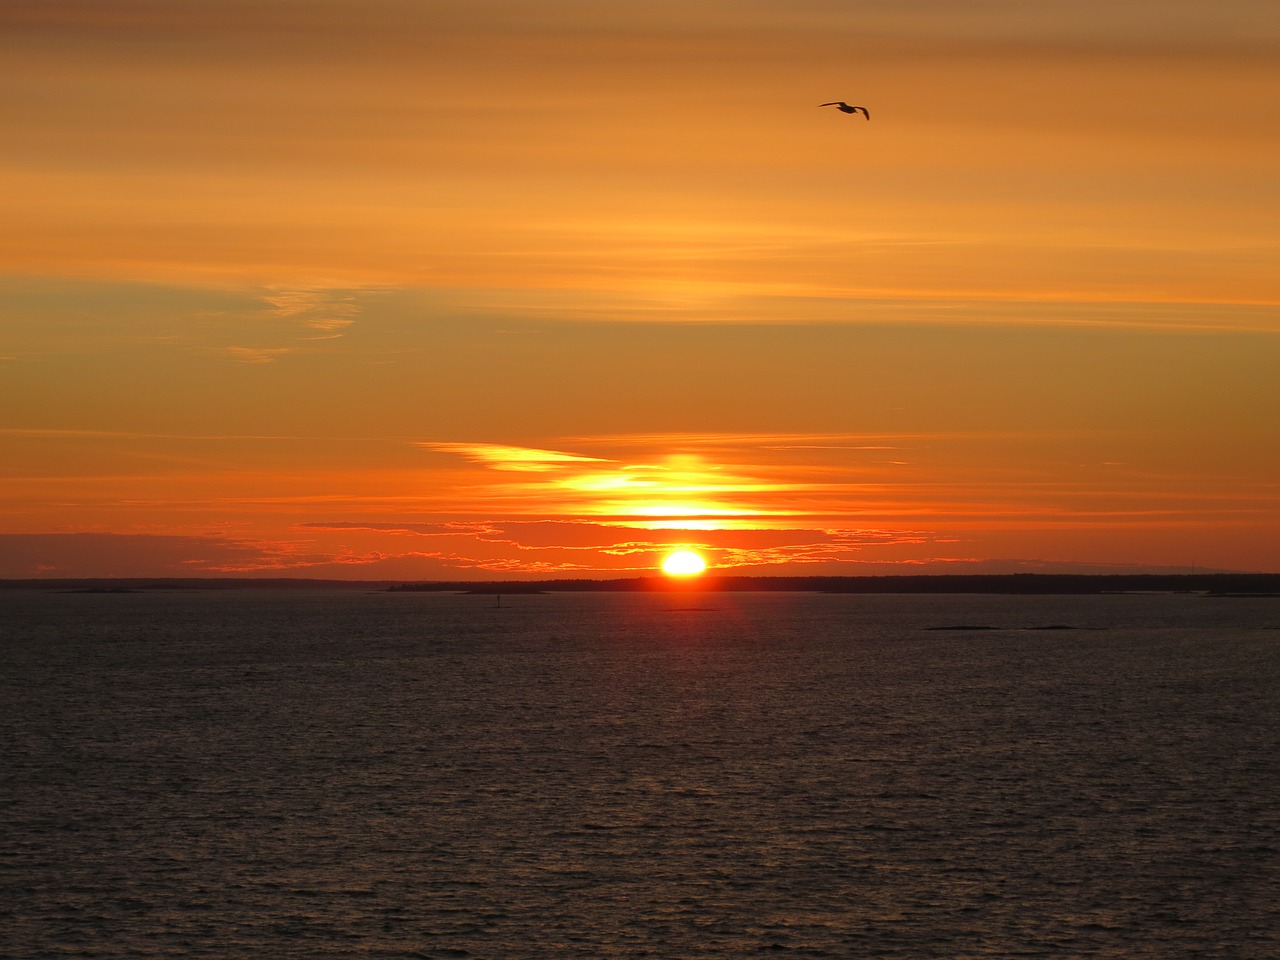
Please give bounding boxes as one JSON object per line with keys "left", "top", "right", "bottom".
{"left": 0, "top": 0, "right": 1280, "bottom": 580}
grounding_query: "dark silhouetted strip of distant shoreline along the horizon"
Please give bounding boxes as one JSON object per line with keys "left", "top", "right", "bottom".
{"left": 0, "top": 573, "right": 1280, "bottom": 596}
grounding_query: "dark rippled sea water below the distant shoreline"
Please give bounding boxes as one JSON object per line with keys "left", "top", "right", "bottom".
{"left": 0, "top": 591, "right": 1280, "bottom": 960}
